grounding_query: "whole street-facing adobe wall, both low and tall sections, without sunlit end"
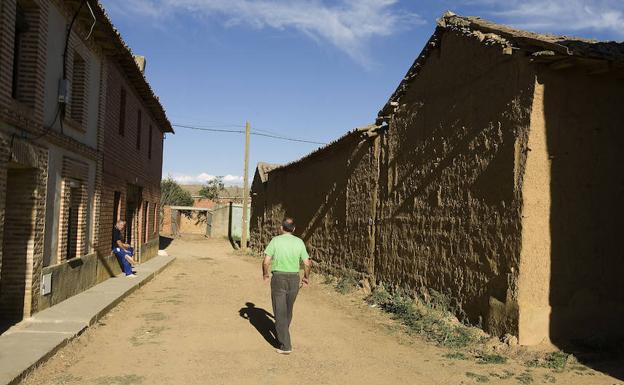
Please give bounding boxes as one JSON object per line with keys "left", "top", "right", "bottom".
{"left": 252, "top": 32, "right": 535, "bottom": 335}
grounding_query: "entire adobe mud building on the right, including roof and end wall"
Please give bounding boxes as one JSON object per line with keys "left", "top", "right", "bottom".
{"left": 251, "top": 14, "right": 624, "bottom": 345}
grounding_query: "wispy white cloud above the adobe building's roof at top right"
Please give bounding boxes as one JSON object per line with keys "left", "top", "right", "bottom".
{"left": 465, "top": 0, "right": 624, "bottom": 38}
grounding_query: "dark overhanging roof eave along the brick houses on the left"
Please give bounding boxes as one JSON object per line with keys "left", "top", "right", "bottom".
{"left": 69, "top": 0, "right": 173, "bottom": 132}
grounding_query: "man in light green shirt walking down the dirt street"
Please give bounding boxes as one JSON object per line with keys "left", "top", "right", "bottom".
{"left": 262, "top": 218, "right": 311, "bottom": 354}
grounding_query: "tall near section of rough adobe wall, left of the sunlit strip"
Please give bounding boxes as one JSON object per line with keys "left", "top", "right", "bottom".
{"left": 375, "top": 32, "right": 535, "bottom": 335}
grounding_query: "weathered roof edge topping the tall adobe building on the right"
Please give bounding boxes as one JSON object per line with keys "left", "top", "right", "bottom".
{"left": 377, "top": 12, "right": 624, "bottom": 123}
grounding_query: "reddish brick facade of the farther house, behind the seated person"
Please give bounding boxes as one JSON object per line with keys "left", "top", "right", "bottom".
{"left": 97, "top": 60, "right": 163, "bottom": 260}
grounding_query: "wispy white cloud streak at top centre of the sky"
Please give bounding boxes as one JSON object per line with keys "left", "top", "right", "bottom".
{"left": 105, "top": 0, "right": 424, "bottom": 65}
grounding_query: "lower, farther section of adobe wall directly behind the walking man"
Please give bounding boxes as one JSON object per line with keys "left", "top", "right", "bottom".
{"left": 250, "top": 133, "right": 376, "bottom": 273}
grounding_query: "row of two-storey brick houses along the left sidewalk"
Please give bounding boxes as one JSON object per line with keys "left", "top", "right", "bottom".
{"left": 0, "top": 0, "right": 172, "bottom": 329}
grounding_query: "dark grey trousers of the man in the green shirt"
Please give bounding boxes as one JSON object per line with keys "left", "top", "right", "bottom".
{"left": 271, "top": 272, "right": 299, "bottom": 350}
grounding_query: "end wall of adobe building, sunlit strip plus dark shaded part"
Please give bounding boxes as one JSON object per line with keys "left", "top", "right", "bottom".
{"left": 520, "top": 66, "right": 624, "bottom": 344}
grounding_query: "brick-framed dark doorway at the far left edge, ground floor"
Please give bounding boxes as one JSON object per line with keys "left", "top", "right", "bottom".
{"left": 0, "top": 132, "right": 47, "bottom": 321}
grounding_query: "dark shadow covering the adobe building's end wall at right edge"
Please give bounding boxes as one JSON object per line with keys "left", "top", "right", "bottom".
{"left": 538, "top": 62, "right": 624, "bottom": 380}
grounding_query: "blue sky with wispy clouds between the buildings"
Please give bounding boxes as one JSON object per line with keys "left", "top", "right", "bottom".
{"left": 102, "top": 0, "right": 624, "bottom": 184}
